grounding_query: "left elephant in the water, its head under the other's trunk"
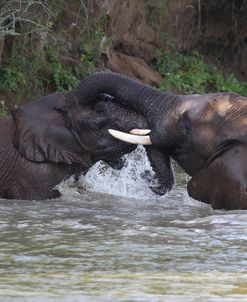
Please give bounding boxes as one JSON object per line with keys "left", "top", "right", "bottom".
{"left": 0, "top": 79, "right": 146, "bottom": 200}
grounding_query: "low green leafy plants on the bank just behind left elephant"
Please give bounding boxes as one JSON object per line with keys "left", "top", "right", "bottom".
{"left": 0, "top": 45, "right": 96, "bottom": 106}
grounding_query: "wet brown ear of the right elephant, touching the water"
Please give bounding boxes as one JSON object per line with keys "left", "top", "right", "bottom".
{"left": 188, "top": 144, "right": 247, "bottom": 210}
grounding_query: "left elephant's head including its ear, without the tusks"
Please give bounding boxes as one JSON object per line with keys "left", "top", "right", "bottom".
{"left": 12, "top": 88, "right": 146, "bottom": 169}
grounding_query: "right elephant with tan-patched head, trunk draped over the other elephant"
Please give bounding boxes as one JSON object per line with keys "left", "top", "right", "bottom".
{"left": 75, "top": 73, "right": 247, "bottom": 209}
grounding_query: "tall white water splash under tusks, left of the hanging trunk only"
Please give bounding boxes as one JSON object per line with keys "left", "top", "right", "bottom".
{"left": 79, "top": 146, "right": 157, "bottom": 199}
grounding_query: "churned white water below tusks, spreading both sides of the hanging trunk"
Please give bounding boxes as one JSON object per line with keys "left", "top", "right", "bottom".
{"left": 58, "top": 146, "right": 204, "bottom": 207}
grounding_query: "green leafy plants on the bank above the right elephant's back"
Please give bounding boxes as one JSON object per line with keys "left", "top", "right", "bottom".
{"left": 155, "top": 50, "right": 247, "bottom": 96}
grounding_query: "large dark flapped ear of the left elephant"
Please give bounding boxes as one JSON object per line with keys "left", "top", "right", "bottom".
{"left": 12, "top": 93, "right": 90, "bottom": 167}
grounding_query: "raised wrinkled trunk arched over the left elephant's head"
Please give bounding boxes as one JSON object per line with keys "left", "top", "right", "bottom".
{"left": 72, "top": 72, "right": 176, "bottom": 116}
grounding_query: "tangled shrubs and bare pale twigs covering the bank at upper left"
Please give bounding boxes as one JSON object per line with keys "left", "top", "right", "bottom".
{"left": 0, "top": 0, "right": 108, "bottom": 114}
